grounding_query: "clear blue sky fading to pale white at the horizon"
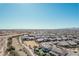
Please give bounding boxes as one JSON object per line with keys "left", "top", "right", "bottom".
{"left": 0, "top": 3, "right": 79, "bottom": 29}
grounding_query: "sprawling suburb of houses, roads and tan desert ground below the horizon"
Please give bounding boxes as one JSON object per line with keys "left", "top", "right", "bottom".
{"left": 0, "top": 29, "right": 79, "bottom": 56}
